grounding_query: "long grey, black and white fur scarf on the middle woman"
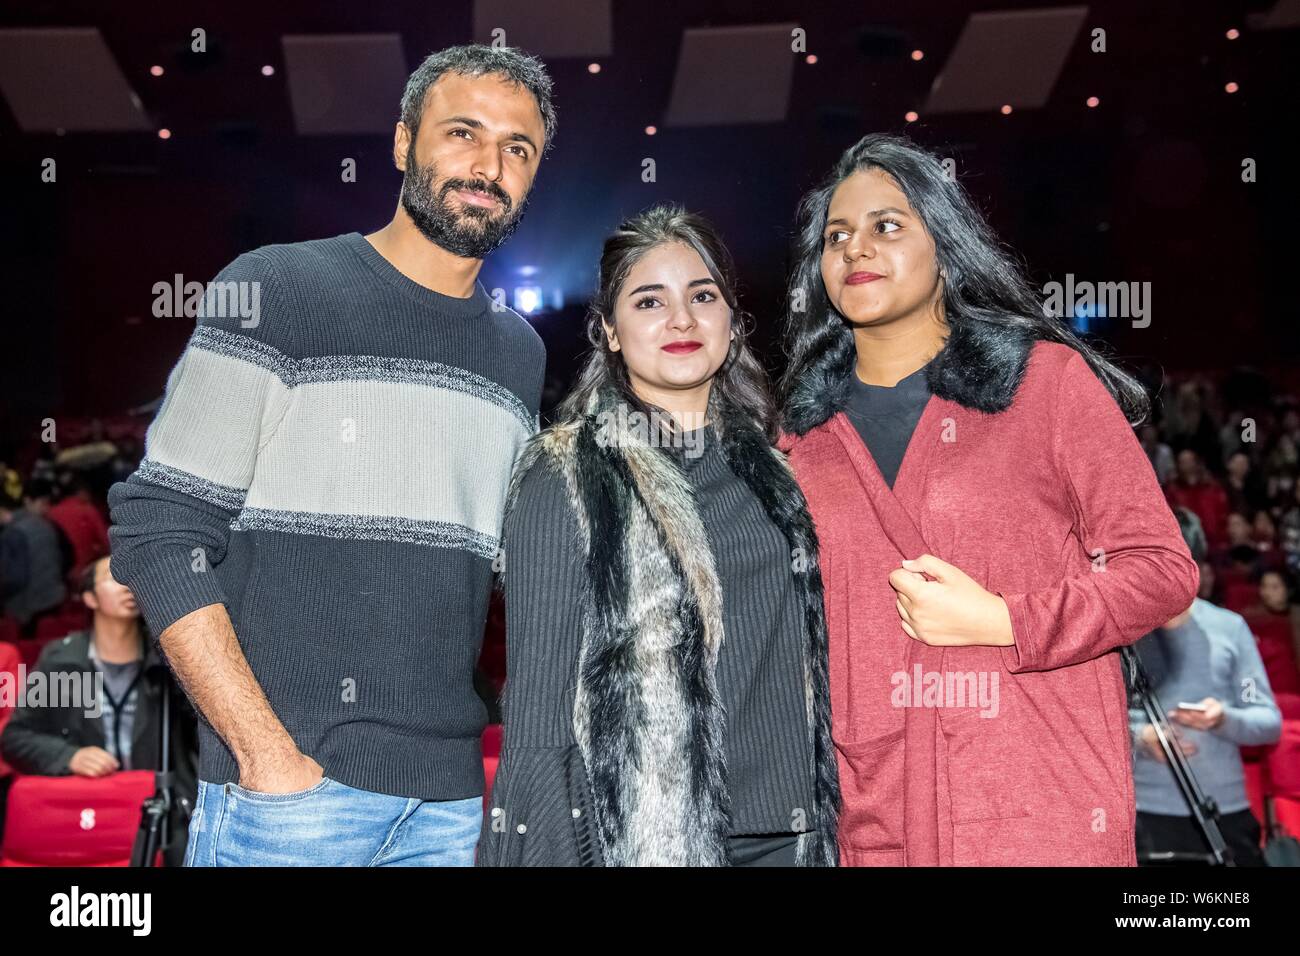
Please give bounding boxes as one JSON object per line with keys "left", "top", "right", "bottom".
{"left": 506, "top": 388, "right": 840, "bottom": 866}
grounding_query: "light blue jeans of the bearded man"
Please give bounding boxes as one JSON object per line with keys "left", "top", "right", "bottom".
{"left": 185, "top": 777, "right": 482, "bottom": 866}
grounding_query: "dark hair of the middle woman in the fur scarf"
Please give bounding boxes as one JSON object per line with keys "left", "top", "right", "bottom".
{"left": 558, "top": 204, "right": 776, "bottom": 441}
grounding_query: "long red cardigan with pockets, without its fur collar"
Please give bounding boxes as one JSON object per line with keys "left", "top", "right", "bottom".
{"left": 781, "top": 342, "right": 1199, "bottom": 866}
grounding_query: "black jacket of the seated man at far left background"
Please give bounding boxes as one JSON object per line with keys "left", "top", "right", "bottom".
{"left": 0, "top": 631, "right": 199, "bottom": 865}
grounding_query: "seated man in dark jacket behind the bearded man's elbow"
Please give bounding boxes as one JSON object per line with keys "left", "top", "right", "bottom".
{"left": 0, "top": 558, "right": 198, "bottom": 865}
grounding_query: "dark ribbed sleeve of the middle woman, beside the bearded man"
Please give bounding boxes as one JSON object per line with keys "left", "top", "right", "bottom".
{"left": 477, "top": 459, "right": 599, "bottom": 866}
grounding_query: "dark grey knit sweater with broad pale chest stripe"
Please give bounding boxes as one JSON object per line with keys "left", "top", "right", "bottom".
{"left": 109, "top": 233, "right": 546, "bottom": 800}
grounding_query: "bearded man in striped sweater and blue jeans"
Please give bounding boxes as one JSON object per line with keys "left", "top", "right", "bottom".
{"left": 109, "top": 46, "right": 555, "bottom": 866}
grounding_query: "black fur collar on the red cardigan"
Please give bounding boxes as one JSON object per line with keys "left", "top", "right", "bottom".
{"left": 784, "top": 320, "right": 1035, "bottom": 434}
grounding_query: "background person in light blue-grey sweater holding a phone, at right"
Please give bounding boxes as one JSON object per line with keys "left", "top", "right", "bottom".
{"left": 1128, "top": 509, "right": 1282, "bottom": 866}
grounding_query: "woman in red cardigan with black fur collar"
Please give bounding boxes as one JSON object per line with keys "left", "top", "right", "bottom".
{"left": 781, "top": 135, "right": 1197, "bottom": 866}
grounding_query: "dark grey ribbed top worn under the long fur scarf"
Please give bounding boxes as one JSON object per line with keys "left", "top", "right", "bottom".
{"left": 478, "top": 425, "right": 815, "bottom": 866}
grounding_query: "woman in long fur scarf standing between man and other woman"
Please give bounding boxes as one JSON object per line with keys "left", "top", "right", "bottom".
{"left": 478, "top": 207, "right": 839, "bottom": 866}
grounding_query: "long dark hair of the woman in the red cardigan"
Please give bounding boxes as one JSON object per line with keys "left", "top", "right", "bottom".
{"left": 780, "top": 134, "right": 1151, "bottom": 424}
